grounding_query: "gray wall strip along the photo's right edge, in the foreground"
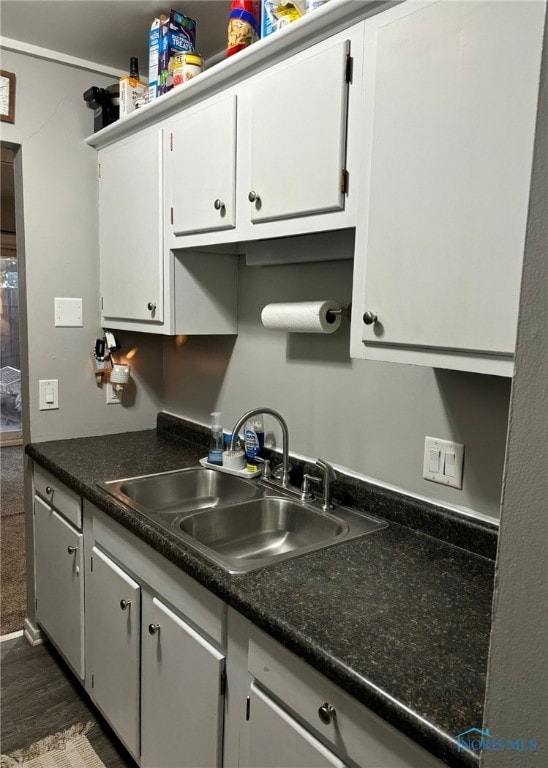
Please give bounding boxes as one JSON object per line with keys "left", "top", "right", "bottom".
{"left": 482, "top": 12, "right": 548, "bottom": 768}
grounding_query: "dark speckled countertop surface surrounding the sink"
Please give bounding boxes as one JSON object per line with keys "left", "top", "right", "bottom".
{"left": 26, "top": 420, "right": 494, "bottom": 767}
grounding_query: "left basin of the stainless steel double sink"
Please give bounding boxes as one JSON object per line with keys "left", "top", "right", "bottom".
{"left": 99, "top": 467, "right": 259, "bottom": 516}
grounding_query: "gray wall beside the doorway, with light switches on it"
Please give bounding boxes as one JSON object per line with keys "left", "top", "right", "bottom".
{"left": 1, "top": 50, "right": 162, "bottom": 441}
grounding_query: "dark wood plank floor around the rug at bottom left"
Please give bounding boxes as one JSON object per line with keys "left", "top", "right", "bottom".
{"left": 0, "top": 637, "right": 136, "bottom": 768}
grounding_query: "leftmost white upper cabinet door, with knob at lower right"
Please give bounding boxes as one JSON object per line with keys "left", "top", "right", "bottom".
{"left": 99, "top": 129, "right": 164, "bottom": 323}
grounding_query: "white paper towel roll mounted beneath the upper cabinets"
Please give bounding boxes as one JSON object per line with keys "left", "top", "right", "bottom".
{"left": 261, "top": 300, "right": 342, "bottom": 333}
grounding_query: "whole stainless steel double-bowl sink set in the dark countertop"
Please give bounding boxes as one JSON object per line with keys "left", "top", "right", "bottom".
{"left": 99, "top": 467, "right": 387, "bottom": 573}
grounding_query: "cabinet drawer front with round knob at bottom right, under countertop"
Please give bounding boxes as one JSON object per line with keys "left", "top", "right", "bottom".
{"left": 248, "top": 633, "right": 442, "bottom": 768}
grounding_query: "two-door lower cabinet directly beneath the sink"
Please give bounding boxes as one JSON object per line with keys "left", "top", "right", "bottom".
{"left": 84, "top": 503, "right": 226, "bottom": 768}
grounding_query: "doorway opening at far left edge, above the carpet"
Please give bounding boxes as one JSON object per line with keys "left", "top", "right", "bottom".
{"left": 0, "top": 145, "right": 23, "bottom": 446}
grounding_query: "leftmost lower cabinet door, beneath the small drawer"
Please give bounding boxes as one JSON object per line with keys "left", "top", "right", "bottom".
{"left": 34, "top": 496, "right": 84, "bottom": 679}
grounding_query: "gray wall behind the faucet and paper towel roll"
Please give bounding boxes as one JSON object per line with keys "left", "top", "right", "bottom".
{"left": 163, "top": 249, "right": 510, "bottom": 517}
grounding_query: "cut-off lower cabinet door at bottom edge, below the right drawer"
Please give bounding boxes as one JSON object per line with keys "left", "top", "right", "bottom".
{"left": 247, "top": 683, "right": 345, "bottom": 768}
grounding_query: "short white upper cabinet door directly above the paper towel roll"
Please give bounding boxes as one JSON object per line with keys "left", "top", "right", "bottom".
{"left": 248, "top": 41, "right": 349, "bottom": 222}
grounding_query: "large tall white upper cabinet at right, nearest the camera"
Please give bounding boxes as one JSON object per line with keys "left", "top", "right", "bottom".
{"left": 352, "top": 0, "right": 544, "bottom": 375}
